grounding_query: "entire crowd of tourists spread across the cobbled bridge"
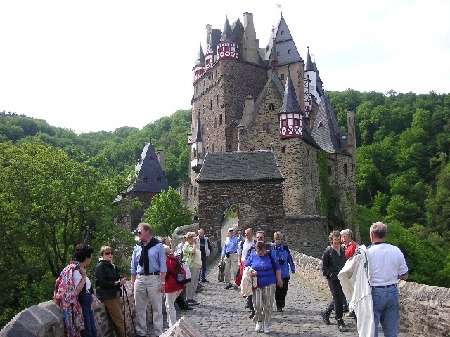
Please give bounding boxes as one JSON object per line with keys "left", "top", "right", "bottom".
{"left": 54, "top": 222, "right": 408, "bottom": 337}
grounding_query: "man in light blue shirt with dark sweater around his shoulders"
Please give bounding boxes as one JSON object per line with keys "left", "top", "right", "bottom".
{"left": 130, "top": 223, "right": 167, "bottom": 336}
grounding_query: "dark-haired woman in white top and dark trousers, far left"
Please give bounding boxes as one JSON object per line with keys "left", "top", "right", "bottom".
{"left": 73, "top": 243, "right": 97, "bottom": 337}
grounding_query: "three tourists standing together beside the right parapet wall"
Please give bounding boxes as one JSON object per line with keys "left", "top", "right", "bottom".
{"left": 321, "top": 222, "right": 408, "bottom": 337}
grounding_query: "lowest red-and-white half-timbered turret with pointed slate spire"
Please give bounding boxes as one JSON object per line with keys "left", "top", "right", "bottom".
{"left": 279, "top": 68, "right": 303, "bottom": 138}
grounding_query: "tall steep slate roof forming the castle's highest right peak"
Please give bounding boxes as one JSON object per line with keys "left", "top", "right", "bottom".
{"left": 265, "top": 16, "right": 302, "bottom": 66}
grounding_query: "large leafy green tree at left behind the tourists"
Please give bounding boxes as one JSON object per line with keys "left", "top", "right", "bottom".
{"left": 0, "top": 142, "right": 131, "bottom": 324}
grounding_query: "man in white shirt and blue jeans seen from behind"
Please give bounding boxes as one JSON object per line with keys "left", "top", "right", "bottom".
{"left": 367, "top": 222, "right": 408, "bottom": 337}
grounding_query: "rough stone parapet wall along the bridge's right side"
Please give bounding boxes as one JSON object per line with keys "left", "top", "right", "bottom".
{"left": 291, "top": 251, "right": 450, "bottom": 337}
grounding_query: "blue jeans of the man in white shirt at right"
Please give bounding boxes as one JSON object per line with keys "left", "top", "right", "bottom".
{"left": 372, "top": 286, "right": 399, "bottom": 337}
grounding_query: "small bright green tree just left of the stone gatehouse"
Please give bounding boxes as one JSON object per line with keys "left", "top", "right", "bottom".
{"left": 143, "top": 187, "right": 192, "bottom": 236}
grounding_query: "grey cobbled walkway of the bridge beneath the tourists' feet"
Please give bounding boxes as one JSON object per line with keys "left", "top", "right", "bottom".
{"left": 177, "top": 267, "right": 358, "bottom": 337}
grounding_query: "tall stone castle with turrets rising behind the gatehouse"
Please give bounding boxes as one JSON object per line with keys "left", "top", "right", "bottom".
{"left": 183, "top": 13, "right": 356, "bottom": 234}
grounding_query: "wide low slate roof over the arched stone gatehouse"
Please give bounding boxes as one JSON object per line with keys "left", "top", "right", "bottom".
{"left": 196, "top": 151, "right": 284, "bottom": 182}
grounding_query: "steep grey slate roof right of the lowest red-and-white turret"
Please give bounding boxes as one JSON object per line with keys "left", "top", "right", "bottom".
{"left": 311, "top": 94, "right": 347, "bottom": 154}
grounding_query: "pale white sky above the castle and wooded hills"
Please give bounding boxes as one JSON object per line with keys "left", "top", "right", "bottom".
{"left": 0, "top": 0, "right": 450, "bottom": 133}
